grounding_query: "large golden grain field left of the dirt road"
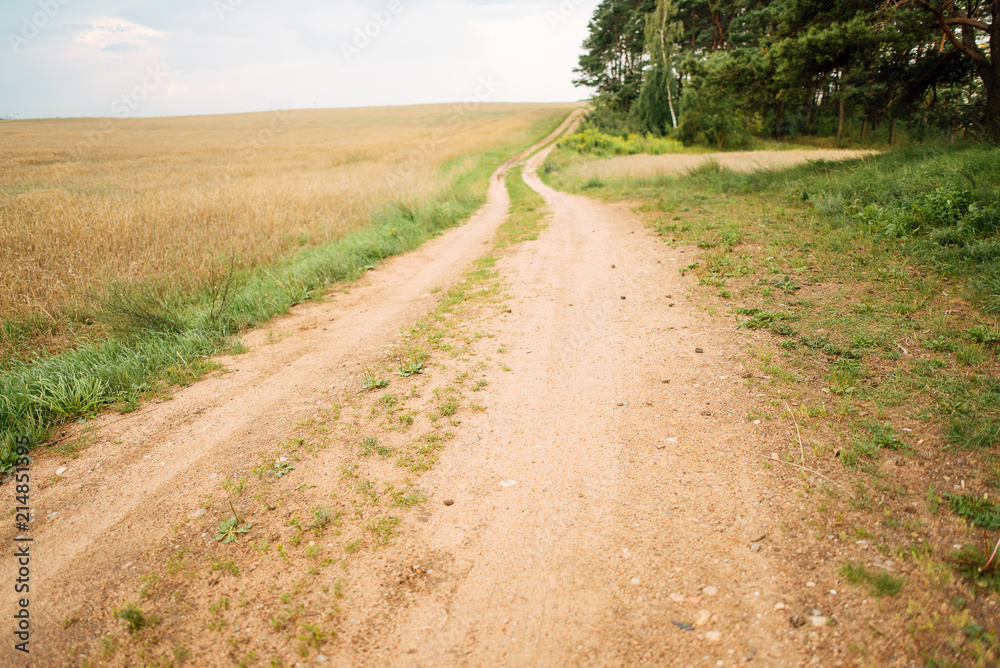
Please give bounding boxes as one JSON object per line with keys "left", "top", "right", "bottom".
{"left": 0, "top": 104, "right": 572, "bottom": 332}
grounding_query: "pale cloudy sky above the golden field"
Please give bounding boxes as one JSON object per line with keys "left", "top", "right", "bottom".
{"left": 0, "top": 0, "right": 599, "bottom": 118}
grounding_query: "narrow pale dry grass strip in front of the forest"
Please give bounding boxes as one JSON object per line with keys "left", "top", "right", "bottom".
{"left": 570, "top": 149, "right": 873, "bottom": 180}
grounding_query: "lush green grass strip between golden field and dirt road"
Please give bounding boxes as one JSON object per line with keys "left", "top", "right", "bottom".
{"left": 0, "top": 112, "right": 561, "bottom": 470}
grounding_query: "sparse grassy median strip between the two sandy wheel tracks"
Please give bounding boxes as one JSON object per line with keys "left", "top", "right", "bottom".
{"left": 62, "top": 160, "right": 543, "bottom": 666}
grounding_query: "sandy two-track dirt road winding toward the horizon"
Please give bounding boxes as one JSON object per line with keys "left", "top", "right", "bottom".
{"left": 0, "top": 116, "right": 856, "bottom": 666}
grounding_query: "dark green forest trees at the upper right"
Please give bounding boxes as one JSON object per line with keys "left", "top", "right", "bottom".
{"left": 576, "top": 0, "right": 1000, "bottom": 146}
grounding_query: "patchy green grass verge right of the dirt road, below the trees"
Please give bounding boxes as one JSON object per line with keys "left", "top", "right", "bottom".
{"left": 542, "top": 147, "right": 1000, "bottom": 666}
